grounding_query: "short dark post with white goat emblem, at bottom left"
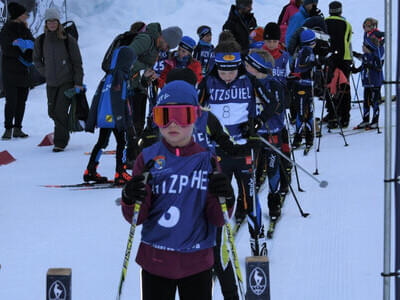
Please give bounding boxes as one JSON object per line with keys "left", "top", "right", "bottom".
{"left": 46, "top": 269, "right": 72, "bottom": 300}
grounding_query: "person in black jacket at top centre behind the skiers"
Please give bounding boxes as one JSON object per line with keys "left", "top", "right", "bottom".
{"left": 222, "top": 0, "right": 257, "bottom": 55}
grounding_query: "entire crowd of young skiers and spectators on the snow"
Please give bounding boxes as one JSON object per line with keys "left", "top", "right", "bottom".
{"left": 0, "top": 0, "right": 384, "bottom": 300}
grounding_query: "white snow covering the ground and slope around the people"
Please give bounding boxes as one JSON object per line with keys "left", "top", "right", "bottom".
{"left": 0, "top": 0, "right": 397, "bottom": 300}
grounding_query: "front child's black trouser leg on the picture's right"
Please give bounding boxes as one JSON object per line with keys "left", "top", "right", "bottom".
{"left": 177, "top": 269, "right": 212, "bottom": 300}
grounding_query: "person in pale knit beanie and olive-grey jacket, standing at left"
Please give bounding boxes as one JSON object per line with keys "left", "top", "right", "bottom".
{"left": 33, "top": 8, "right": 83, "bottom": 152}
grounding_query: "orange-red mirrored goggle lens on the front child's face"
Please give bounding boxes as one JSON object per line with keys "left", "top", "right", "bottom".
{"left": 153, "top": 105, "right": 201, "bottom": 128}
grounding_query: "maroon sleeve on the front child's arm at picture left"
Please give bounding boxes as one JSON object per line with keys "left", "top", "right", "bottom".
{"left": 121, "top": 153, "right": 151, "bottom": 225}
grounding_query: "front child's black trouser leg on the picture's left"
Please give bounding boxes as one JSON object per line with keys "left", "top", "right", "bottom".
{"left": 142, "top": 269, "right": 177, "bottom": 300}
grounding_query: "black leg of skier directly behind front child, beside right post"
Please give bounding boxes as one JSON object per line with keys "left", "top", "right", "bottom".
{"left": 214, "top": 227, "right": 239, "bottom": 300}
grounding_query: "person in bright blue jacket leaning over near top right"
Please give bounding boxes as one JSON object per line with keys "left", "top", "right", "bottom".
{"left": 285, "top": 0, "right": 321, "bottom": 45}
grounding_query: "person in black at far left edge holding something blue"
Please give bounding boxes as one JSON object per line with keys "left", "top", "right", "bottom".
{"left": 0, "top": 2, "right": 34, "bottom": 140}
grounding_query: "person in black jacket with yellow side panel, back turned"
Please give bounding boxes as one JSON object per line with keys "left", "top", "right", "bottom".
{"left": 325, "top": 1, "right": 353, "bottom": 128}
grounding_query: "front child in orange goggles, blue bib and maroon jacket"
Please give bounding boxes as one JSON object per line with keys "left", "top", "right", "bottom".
{"left": 122, "top": 80, "right": 234, "bottom": 300}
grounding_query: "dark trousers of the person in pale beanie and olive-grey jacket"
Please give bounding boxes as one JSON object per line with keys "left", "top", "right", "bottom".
{"left": 47, "top": 83, "right": 73, "bottom": 148}
